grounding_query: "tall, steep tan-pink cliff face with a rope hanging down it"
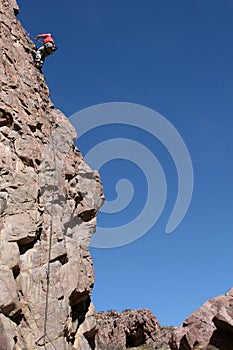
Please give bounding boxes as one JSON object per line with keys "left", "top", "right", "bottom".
{"left": 0, "top": 0, "right": 103, "bottom": 350}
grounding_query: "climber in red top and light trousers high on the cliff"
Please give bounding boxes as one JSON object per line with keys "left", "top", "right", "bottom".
{"left": 35, "top": 34, "right": 57, "bottom": 68}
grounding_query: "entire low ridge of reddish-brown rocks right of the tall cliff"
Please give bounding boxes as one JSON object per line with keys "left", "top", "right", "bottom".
{"left": 96, "top": 288, "right": 233, "bottom": 350}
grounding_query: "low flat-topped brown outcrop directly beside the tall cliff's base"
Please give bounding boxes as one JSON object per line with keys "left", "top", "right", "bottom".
{"left": 96, "top": 309, "right": 173, "bottom": 350}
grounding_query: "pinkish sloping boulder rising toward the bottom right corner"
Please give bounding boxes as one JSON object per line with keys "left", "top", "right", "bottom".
{"left": 170, "top": 288, "right": 233, "bottom": 350}
